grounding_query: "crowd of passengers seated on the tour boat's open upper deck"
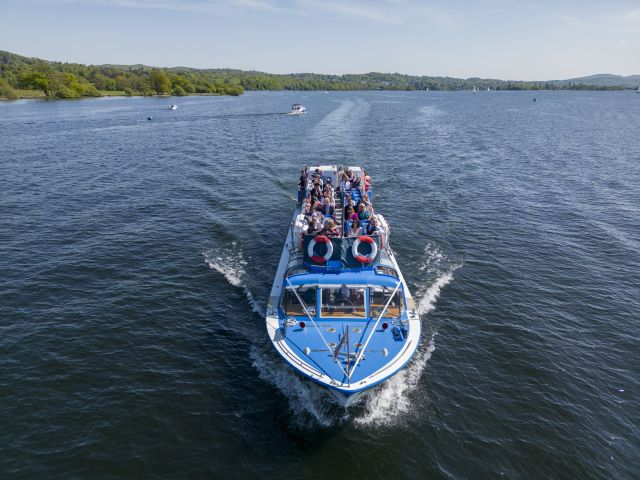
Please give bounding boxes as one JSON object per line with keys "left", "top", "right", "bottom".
{"left": 298, "top": 169, "right": 382, "bottom": 237}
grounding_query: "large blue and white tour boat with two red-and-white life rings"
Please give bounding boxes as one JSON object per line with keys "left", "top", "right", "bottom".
{"left": 266, "top": 165, "right": 421, "bottom": 407}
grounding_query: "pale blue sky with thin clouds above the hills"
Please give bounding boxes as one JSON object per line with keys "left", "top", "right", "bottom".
{"left": 0, "top": 0, "right": 640, "bottom": 80}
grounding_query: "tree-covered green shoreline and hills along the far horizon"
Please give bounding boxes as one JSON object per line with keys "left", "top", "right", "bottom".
{"left": 0, "top": 51, "right": 640, "bottom": 98}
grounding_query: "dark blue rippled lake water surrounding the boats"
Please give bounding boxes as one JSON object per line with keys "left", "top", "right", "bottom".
{"left": 0, "top": 92, "right": 640, "bottom": 479}
